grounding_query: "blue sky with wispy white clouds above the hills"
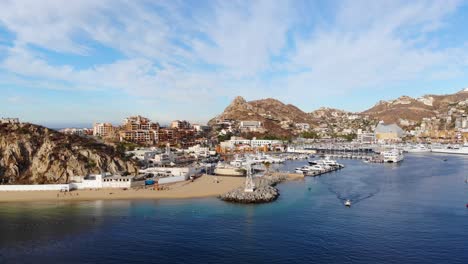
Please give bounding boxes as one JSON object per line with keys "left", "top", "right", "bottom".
{"left": 0, "top": 0, "right": 468, "bottom": 127}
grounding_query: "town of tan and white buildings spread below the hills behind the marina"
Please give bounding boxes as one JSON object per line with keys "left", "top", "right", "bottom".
{"left": 0, "top": 91, "right": 468, "bottom": 155}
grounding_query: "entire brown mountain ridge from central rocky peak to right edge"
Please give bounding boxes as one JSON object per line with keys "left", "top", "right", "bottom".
{"left": 208, "top": 88, "right": 468, "bottom": 136}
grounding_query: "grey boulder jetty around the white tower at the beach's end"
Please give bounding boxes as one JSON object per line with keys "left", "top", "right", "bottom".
{"left": 219, "top": 175, "right": 287, "bottom": 204}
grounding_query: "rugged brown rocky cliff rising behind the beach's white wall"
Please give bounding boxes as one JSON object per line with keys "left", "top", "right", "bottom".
{"left": 0, "top": 124, "right": 137, "bottom": 184}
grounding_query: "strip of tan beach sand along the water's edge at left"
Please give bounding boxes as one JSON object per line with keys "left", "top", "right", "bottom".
{"left": 0, "top": 175, "right": 245, "bottom": 202}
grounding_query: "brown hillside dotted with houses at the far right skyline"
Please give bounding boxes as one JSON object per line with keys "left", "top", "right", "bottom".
{"left": 361, "top": 88, "right": 468, "bottom": 126}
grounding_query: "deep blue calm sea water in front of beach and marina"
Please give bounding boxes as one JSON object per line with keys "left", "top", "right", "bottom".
{"left": 0, "top": 154, "right": 468, "bottom": 263}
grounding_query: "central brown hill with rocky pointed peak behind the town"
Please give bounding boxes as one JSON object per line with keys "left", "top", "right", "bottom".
{"left": 208, "top": 96, "right": 314, "bottom": 136}
